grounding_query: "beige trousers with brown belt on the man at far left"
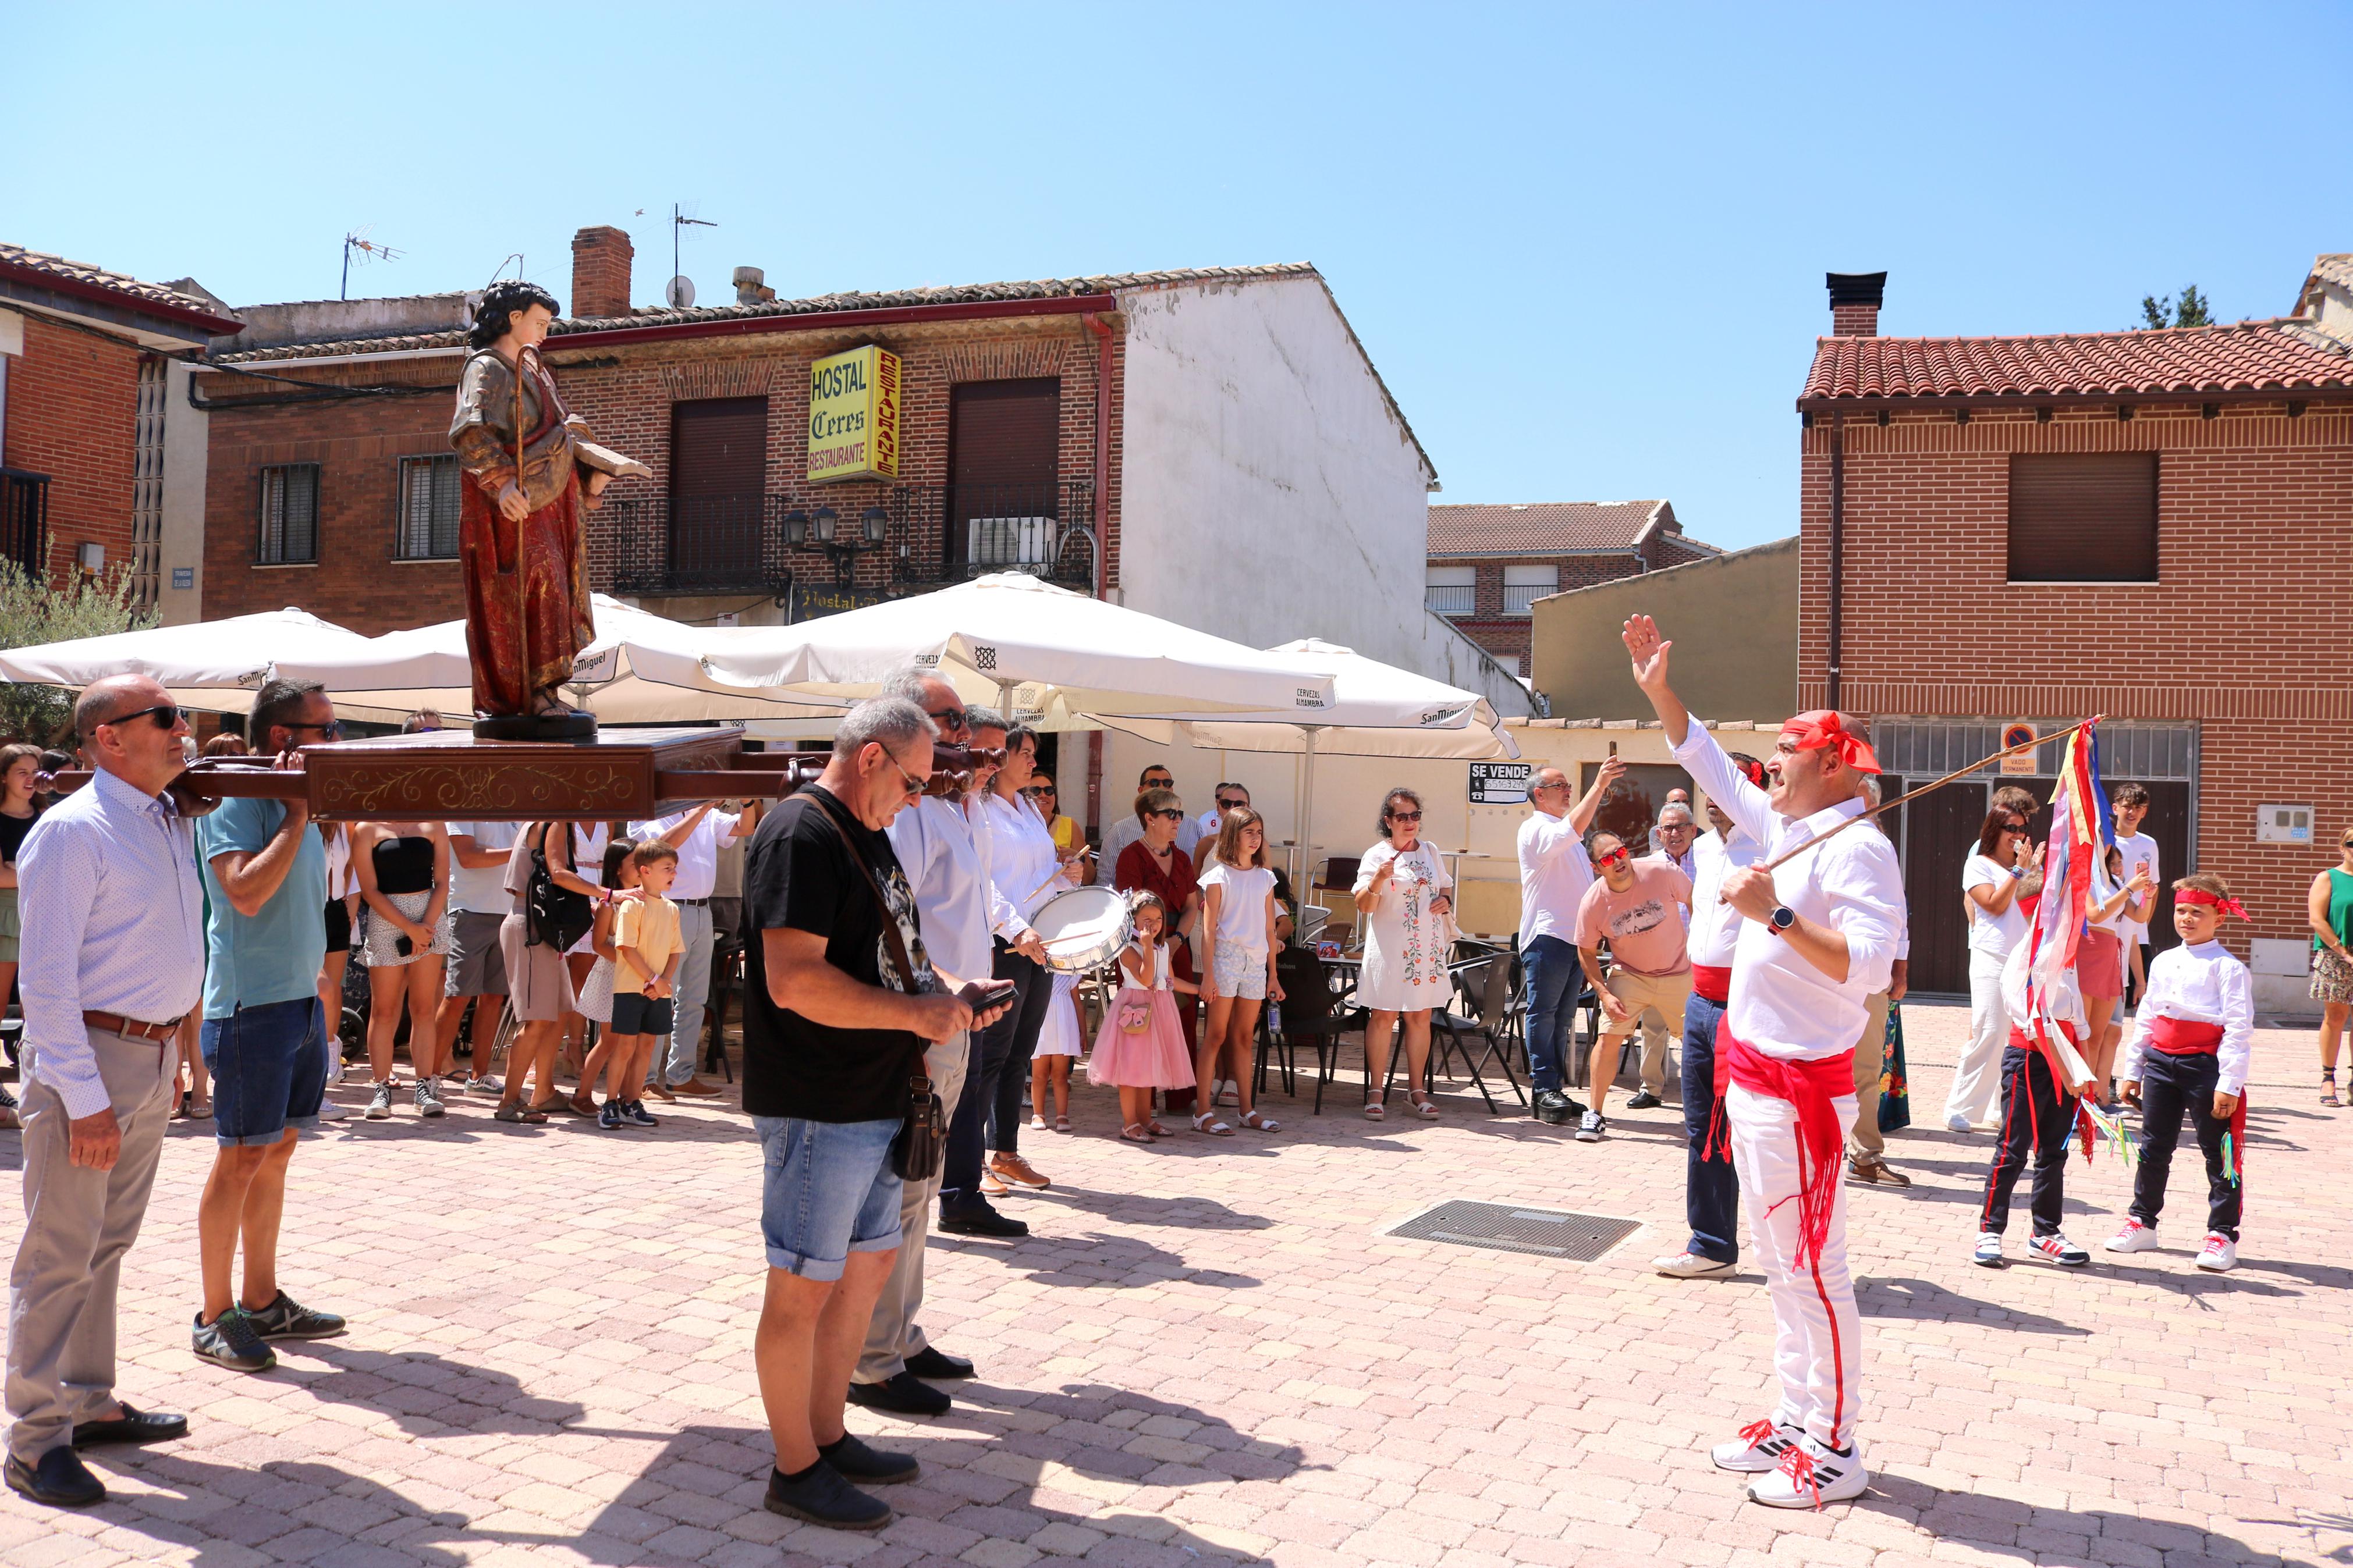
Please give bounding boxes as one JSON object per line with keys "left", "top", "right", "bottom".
{"left": 7, "top": 1030, "right": 179, "bottom": 1464}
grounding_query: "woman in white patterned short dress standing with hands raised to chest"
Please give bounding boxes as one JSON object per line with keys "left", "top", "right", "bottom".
{"left": 1353, "top": 790, "right": 1454, "bottom": 1121}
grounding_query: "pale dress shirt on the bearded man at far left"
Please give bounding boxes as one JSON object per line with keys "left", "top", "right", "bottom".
{"left": 16, "top": 769, "right": 205, "bottom": 1121}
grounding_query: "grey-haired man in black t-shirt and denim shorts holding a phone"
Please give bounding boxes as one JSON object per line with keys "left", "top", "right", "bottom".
{"left": 744, "top": 698, "right": 995, "bottom": 1530}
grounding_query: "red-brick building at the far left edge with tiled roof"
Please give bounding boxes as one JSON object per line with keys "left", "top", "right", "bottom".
{"left": 0, "top": 244, "right": 237, "bottom": 609}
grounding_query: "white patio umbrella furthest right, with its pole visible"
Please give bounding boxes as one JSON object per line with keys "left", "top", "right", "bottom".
{"left": 1087, "top": 637, "right": 1520, "bottom": 872}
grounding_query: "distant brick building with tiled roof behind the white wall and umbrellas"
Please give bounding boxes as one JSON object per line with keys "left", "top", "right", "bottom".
{"left": 1426, "top": 501, "right": 1720, "bottom": 675}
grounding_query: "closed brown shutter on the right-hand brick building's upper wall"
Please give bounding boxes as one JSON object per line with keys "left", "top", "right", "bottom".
{"left": 2010, "top": 451, "right": 2157, "bottom": 583}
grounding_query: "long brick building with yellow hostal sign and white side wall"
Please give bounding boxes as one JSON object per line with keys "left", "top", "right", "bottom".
{"left": 198, "top": 228, "right": 1529, "bottom": 827}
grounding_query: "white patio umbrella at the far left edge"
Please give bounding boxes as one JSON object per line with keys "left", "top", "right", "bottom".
{"left": 0, "top": 609, "right": 370, "bottom": 712}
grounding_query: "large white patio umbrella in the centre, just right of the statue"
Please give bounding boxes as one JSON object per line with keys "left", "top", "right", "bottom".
{"left": 638, "top": 571, "right": 1332, "bottom": 729}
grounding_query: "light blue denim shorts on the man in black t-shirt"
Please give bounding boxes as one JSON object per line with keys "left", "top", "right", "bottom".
{"left": 751, "top": 1117, "right": 901, "bottom": 1279}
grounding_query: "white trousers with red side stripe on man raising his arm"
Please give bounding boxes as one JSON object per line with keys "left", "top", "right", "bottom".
{"left": 1725, "top": 1084, "right": 1864, "bottom": 1448}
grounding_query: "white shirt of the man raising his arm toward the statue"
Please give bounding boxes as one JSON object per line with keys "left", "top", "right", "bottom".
{"left": 1676, "top": 719, "right": 1904, "bottom": 1060}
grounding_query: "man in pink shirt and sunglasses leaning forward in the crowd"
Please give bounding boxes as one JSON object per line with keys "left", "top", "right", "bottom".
{"left": 1577, "top": 830, "right": 1692, "bottom": 1143}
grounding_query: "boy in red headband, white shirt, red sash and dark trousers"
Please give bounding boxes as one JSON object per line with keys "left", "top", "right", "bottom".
{"left": 2109, "top": 872, "right": 2254, "bottom": 1272}
